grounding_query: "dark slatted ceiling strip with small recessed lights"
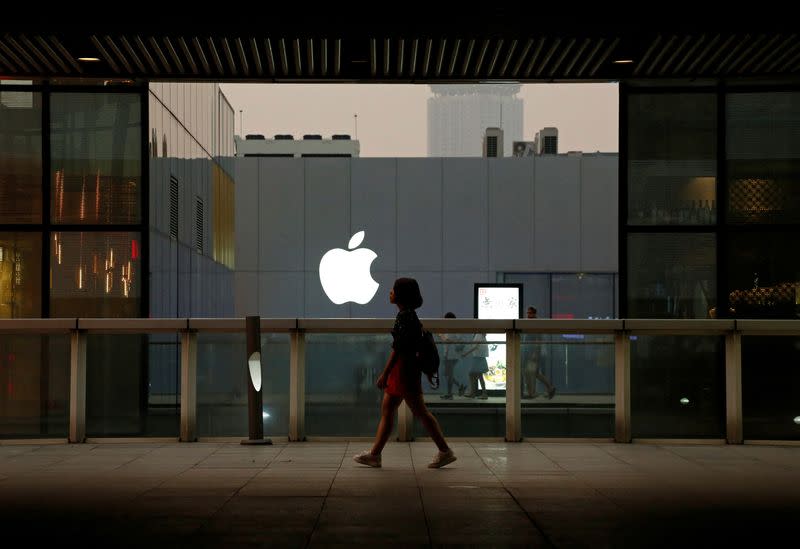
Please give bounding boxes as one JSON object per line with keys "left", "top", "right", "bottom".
{"left": 0, "top": 30, "right": 800, "bottom": 82}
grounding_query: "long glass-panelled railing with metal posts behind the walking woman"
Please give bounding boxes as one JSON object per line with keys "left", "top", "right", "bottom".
{"left": 0, "top": 318, "right": 800, "bottom": 443}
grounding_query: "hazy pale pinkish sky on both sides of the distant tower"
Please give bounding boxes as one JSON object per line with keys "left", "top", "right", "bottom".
{"left": 221, "top": 84, "right": 619, "bottom": 157}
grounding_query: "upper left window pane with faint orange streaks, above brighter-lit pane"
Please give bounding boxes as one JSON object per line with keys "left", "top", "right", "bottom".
{"left": 50, "top": 93, "right": 142, "bottom": 224}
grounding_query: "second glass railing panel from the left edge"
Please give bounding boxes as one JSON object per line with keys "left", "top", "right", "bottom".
{"left": 86, "top": 334, "right": 180, "bottom": 437}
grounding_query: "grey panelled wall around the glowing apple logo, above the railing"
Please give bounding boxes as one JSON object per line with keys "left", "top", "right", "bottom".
{"left": 235, "top": 153, "right": 617, "bottom": 318}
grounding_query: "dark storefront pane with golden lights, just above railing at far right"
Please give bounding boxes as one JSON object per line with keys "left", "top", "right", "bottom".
{"left": 727, "top": 231, "right": 800, "bottom": 319}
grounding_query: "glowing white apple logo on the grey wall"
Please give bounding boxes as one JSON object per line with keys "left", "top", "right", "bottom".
{"left": 319, "top": 231, "right": 379, "bottom": 305}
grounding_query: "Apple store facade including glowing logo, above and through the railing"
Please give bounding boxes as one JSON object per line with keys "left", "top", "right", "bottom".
{"left": 231, "top": 153, "right": 618, "bottom": 437}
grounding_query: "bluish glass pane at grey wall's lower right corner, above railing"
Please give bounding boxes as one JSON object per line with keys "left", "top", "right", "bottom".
{"left": 552, "top": 273, "right": 616, "bottom": 319}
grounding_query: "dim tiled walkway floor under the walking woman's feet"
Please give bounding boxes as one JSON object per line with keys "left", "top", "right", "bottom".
{"left": 0, "top": 442, "right": 800, "bottom": 549}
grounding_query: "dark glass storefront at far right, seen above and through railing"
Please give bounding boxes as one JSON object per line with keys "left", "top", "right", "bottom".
{"left": 621, "top": 88, "right": 800, "bottom": 439}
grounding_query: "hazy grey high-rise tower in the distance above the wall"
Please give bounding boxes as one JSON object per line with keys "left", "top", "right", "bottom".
{"left": 428, "top": 84, "right": 523, "bottom": 156}
